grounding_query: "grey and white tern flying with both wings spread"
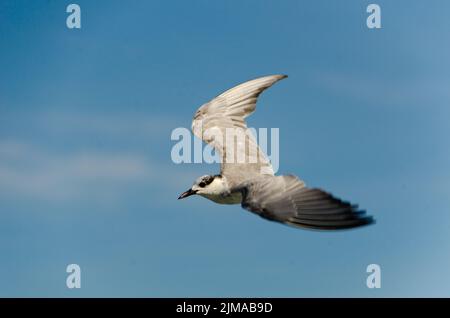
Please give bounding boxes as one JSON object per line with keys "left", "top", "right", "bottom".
{"left": 178, "top": 75, "right": 374, "bottom": 230}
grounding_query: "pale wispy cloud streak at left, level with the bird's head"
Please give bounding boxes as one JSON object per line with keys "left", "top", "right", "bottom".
{"left": 0, "top": 141, "right": 153, "bottom": 200}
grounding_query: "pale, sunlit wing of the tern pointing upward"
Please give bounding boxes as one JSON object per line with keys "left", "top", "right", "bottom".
{"left": 192, "top": 75, "right": 286, "bottom": 186}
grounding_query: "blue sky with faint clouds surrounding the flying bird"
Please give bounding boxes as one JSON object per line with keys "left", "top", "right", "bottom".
{"left": 0, "top": 0, "right": 450, "bottom": 297}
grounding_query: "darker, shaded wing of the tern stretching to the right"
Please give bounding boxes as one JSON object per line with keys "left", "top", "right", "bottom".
{"left": 240, "top": 175, "right": 374, "bottom": 230}
